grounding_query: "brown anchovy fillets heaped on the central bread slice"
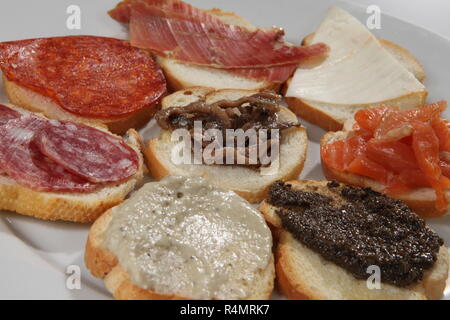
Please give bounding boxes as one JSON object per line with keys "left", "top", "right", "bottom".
{"left": 155, "top": 92, "right": 300, "bottom": 168}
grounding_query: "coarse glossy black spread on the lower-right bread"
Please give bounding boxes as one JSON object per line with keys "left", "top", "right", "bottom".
{"left": 268, "top": 181, "right": 443, "bottom": 286}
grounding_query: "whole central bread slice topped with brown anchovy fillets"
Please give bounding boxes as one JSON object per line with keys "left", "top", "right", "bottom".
{"left": 145, "top": 88, "right": 307, "bottom": 202}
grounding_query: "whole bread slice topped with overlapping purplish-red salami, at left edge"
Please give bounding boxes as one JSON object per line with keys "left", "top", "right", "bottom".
{"left": 0, "top": 105, "right": 144, "bottom": 222}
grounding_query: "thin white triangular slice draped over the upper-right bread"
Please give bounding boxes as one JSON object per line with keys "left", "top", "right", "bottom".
{"left": 286, "top": 7, "right": 425, "bottom": 105}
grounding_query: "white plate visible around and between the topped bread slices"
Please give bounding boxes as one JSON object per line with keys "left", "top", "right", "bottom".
{"left": 0, "top": 0, "right": 450, "bottom": 299}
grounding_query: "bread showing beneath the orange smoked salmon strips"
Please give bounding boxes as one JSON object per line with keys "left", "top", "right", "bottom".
{"left": 320, "top": 131, "right": 450, "bottom": 218}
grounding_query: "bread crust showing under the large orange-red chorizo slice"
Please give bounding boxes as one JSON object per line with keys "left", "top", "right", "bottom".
{"left": 3, "top": 76, "right": 159, "bottom": 134}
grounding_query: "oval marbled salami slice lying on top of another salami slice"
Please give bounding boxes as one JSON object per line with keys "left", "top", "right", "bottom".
{"left": 36, "top": 121, "right": 139, "bottom": 183}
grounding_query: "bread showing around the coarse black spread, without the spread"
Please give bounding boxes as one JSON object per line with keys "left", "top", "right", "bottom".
{"left": 260, "top": 180, "right": 449, "bottom": 300}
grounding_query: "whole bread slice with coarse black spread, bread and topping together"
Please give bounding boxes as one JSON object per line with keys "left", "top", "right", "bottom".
{"left": 260, "top": 180, "right": 448, "bottom": 300}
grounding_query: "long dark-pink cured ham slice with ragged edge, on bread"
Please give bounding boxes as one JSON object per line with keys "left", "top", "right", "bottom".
{"left": 109, "top": 0, "right": 328, "bottom": 82}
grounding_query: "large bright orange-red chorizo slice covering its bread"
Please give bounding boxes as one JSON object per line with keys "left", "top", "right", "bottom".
{"left": 0, "top": 36, "right": 166, "bottom": 119}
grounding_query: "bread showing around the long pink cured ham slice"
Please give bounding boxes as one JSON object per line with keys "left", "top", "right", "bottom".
{"left": 156, "top": 9, "right": 281, "bottom": 91}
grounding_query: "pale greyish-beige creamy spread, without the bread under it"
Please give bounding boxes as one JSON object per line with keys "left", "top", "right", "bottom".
{"left": 103, "top": 177, "right": 272, "bottom": 299}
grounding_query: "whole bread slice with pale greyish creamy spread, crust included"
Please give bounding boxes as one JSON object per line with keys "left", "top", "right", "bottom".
{"left": 85, "top": 177, "right": 275, "bottom": 300}
